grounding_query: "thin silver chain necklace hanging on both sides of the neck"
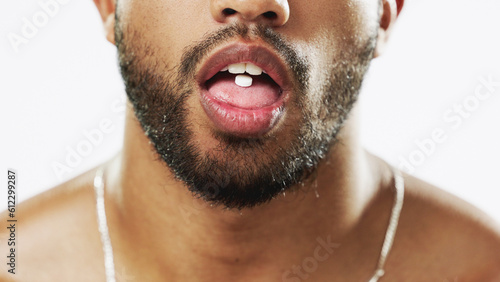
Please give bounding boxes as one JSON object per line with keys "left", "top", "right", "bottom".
{"left": 94, "top": 169, "right": 405, "bottom": 282}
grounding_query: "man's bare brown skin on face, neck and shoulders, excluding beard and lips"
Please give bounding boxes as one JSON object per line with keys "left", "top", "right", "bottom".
{"left": 0, "top": 0, "right": 500, "bottom": 281}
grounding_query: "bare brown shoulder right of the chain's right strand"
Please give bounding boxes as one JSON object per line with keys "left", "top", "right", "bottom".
{"left": 388, "top": 175, "right": 500, "bottom": 282}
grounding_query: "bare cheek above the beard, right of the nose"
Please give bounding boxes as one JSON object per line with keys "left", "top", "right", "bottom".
{"left": 283, "top": 0, "right": 379, "bottom": 89}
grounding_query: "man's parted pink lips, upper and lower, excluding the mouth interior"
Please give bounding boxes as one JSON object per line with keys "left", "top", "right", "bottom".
{"left": 196, "top": 43, "right": 291, "bottom": 137}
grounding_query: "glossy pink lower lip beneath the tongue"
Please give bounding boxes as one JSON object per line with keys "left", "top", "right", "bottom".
{"left": 201, "top": 90, "right": 285, "bottom": 137}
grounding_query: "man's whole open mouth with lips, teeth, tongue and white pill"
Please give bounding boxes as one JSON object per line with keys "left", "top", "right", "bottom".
{"left": 197, "top": 44, "right": 289, "bottom": 137}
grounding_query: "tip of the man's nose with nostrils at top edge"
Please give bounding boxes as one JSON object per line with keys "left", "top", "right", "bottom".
{"left": 210, "top": 0, "right": 290, "bottom": 27}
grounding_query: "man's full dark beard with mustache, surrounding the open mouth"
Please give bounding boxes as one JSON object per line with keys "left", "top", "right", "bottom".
{"left": 115, "top": 16, "right": 376, "bottom": 209}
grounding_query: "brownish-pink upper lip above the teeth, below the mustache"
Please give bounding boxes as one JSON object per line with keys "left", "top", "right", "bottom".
{"left": 196, "top": 42, "right": 290, "bottom": 90}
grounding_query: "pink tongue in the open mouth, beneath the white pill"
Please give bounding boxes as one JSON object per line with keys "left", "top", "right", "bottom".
{"left": 207, "top": 72, "right": 281, "bottom": 109}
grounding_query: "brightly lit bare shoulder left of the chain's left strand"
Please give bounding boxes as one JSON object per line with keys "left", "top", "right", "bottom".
{"left": 0, "top": 167, "right": 106, "bottom": 281}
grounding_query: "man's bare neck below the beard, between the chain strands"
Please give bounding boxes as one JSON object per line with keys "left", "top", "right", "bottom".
{"left": 105, "top": 103, "right": 380, "bottom": 281}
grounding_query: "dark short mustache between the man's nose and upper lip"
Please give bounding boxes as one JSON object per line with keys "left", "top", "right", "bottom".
{"left": 178, "top": 23, "right": 309, "bottom": 90}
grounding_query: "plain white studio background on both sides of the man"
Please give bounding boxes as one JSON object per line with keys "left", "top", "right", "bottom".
{"left": 0, "top": 0, "right": 500, "bottom": 221}
